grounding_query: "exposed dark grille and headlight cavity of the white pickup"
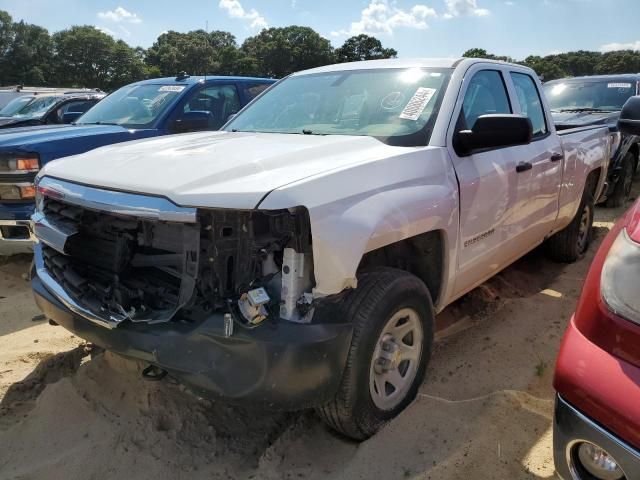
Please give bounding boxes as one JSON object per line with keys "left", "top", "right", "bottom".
{"left": 38, "top": 194, "right": 313, "bottom": 328}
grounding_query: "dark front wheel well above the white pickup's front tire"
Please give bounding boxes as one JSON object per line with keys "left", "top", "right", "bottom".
{"left": 358, "top": 231, "right": 444, "bottom": 304}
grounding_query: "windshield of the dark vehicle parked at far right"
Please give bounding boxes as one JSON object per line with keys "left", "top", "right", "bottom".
{"left": 544, "top": 79, "right": 636, "bottom": 111}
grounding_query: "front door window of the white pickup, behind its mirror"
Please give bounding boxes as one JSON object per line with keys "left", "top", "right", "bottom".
{"left": 460, "top": 70, "right": 512, "bottom": 129}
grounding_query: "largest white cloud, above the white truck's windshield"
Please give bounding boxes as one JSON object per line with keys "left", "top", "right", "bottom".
{"left": 331, "top": 0, "right": 437, "bottom": 37}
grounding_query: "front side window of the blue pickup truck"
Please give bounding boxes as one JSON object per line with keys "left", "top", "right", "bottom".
{"left": 183, "top": 85, "right": 240, "bottom": 130}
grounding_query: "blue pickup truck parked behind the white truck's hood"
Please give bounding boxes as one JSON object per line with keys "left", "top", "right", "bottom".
{"left": 0, "top": 74, "right": 275, "bottom": 255}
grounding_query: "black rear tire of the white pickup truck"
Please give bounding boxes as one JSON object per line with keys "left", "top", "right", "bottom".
{"left": 547, "top": 188, "right": 595, "bottom": 263}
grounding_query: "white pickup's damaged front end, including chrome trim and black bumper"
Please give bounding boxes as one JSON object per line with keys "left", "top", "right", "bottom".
{"left": 32, "top": 177, "right": 351, "bottom": 408}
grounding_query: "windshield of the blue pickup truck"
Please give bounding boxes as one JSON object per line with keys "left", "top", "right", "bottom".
{"left": 76, "top": 84, "right": 186, "bottom": 128}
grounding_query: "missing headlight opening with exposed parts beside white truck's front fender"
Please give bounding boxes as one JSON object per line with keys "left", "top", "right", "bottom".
{"left": 195, "top": 207, "right": 313, "bottom": 328}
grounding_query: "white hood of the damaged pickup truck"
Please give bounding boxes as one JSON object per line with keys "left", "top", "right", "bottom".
{"left": 40, "top": 132, "right": 396, "bottom": 209}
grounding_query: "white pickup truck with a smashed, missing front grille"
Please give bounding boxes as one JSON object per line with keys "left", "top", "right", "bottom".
{"left": 32, "top": 59, "right": 610, "bottom": 439}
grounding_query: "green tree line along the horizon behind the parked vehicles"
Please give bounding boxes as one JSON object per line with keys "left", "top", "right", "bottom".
{"left": 0, "top": 10, "right": 640, "bottom": 91}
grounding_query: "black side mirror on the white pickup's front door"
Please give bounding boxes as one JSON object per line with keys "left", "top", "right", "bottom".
{"left": 454, "top": 114, "right": 533, "bottom": 157}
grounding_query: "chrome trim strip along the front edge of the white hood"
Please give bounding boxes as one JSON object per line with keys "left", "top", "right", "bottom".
{"left": 37, "top": 177, "right": 196, "bottom": 223}
